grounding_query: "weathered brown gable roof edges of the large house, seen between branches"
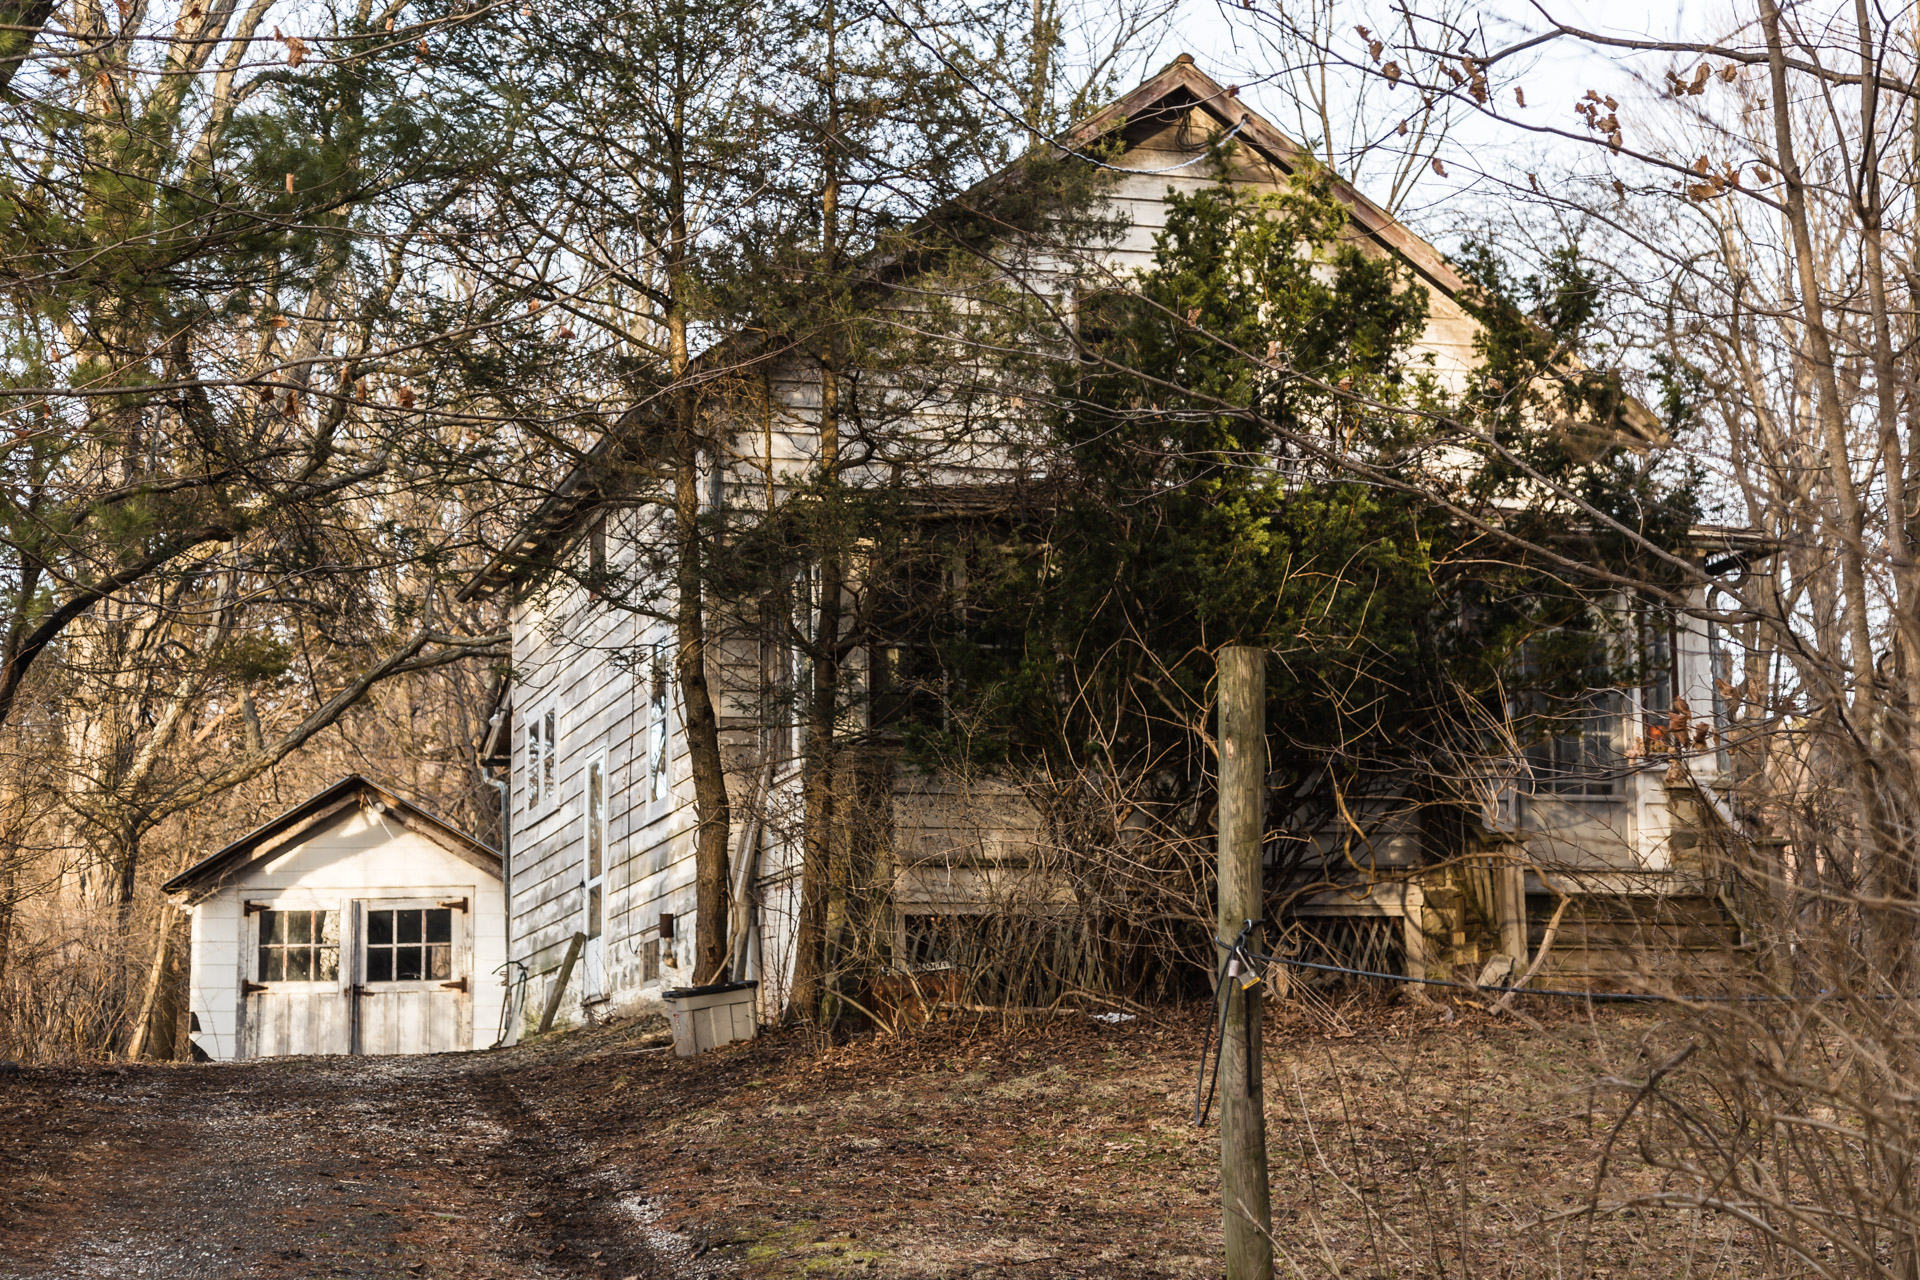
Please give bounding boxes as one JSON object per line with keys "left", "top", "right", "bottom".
{"left": 455, "top": 54, "right": 1667, "bottom": 601}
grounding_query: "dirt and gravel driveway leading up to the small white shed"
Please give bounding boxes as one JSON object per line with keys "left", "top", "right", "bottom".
{"left": 0, "top": 1055, "right": 699, "bottom": 1280}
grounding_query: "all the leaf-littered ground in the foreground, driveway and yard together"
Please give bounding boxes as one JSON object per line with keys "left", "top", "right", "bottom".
{"left": 0, "top": 998, "right": 1780, "bottom": 1280}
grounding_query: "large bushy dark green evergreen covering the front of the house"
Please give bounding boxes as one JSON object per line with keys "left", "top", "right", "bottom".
{"left": 883, "top": 173, "right": 1695, "bottom": 990}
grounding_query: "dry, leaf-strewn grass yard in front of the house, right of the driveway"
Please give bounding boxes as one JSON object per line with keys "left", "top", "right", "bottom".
{"left": 522, "top": 1006, "right": 1759, "bottom": 1280}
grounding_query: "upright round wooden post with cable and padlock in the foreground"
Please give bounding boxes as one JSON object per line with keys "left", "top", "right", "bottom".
{"left": 1217, "top": 645, "right": 1273, "bottom": 1280}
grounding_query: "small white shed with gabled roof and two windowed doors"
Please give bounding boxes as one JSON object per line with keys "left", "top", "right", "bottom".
{"left": 165, "top": 773, "right": 507, "bottom": 1059}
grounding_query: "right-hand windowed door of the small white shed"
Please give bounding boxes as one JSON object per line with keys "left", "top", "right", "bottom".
{"left": 353, "top": 898, "right": 472, "bottom": 1054}
